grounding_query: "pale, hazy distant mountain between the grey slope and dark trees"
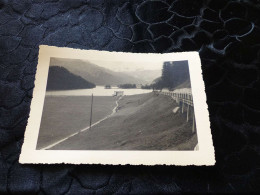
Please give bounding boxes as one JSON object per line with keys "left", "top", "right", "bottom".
{"left": 122, "top": 70, "right": 162, "bottom": 84}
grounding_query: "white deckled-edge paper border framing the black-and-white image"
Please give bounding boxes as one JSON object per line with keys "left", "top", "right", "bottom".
{"left": 19, "top": 45, "right": 215, "bottom": 166}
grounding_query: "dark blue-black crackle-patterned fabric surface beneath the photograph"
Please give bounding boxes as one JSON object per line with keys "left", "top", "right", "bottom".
{"left": 0, "top": 0, "right": 260, "bottom": 194}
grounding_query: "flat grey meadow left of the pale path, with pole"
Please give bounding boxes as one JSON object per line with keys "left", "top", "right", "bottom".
{"left": 37, "top": 96, "right": 116, "bottom": 149}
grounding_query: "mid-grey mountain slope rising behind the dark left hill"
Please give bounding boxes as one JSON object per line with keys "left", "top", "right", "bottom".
{"left": 50, "top": 58, "right": 145, "bottom": 85}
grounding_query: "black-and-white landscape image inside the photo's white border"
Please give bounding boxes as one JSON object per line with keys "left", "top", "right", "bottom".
{"left": 37, "top": 58, "right": 198, "bottom": 150}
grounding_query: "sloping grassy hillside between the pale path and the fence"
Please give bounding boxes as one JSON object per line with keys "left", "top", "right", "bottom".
{"left": 51, "top": 93, "right": 197, "bottom": 150}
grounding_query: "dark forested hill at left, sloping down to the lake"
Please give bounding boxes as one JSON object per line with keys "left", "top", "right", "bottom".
{"left": 47, "top": 66, "right": 95, "bottom": 91}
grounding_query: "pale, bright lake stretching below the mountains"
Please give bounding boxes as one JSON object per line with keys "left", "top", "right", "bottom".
{"left": 46, "top": 86, "right": 152, "bottom": 96}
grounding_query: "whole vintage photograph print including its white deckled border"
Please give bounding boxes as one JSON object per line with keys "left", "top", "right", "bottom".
{"left": 20, "top": 46, "right": 215, "bottom": 165}
